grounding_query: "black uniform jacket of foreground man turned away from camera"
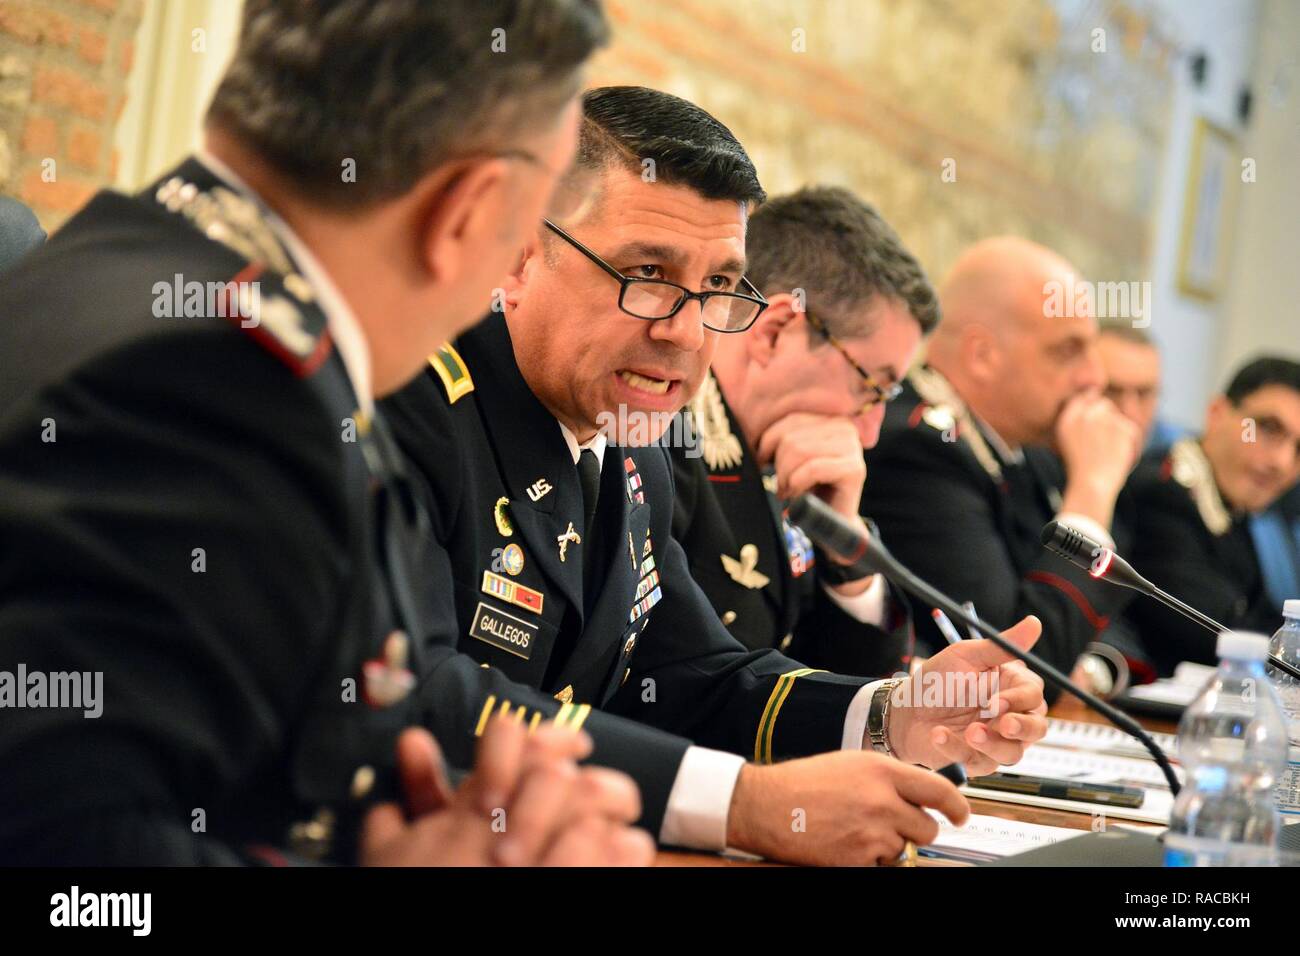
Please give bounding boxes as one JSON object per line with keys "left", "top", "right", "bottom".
{"left": 0, "top": 161, "right": 450, "bottom": 865}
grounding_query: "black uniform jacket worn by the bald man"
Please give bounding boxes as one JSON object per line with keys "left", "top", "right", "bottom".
{"left": 862, "top": 368, "right": 1131, "bottom": 697}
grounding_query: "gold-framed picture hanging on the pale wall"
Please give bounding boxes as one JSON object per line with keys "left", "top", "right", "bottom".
{"left": 1178, "top": 117, "right": 1242, "bottom": 300}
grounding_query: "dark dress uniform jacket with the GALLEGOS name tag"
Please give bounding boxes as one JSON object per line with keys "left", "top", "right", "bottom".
{"left": 382, "top": 315, "right": 866, "bottom": 832}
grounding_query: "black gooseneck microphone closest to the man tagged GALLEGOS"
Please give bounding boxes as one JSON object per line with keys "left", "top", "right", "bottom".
{"left": 788, "top": 494, "right": 1182, "bottom": 796}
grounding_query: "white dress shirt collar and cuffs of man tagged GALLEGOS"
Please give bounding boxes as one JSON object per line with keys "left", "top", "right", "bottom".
{"left": 559, "top": 423, "right": 880, "bottom": 851}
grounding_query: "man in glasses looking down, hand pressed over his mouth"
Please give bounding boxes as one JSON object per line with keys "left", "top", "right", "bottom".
{"left": 670, "top": 186, "right": 939, "bottom": 676}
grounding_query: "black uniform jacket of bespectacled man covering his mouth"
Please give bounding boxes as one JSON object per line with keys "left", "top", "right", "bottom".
{"left": 651, "top": 376, "right": 913, "bottom": 676}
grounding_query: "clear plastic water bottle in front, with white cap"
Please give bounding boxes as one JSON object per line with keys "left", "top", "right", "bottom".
{"left": 1165, "top": 631, "right": 1287, "bottom": 866}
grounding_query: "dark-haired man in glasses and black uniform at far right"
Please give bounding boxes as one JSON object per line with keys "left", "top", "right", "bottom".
{"left": 1127, "top": 356, "right": 1300, "bottom": 674}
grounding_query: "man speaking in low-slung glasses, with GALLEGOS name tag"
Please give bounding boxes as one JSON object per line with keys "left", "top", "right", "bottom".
{"left": 386, "top": 87, "right": 1045, "bottom": 864}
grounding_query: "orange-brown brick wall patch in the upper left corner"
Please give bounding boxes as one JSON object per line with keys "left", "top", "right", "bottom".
{"left": 0, "top": 0, "right": 143, "bottom": 229}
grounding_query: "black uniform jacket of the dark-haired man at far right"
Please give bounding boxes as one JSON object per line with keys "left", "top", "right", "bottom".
{"left": 1127, "top": 438, "right": 1282, "bottom": 675}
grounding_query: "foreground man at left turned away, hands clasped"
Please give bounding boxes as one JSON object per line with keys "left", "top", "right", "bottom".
{"left": 0, "top": 0, "right": 653, "bottom": 865}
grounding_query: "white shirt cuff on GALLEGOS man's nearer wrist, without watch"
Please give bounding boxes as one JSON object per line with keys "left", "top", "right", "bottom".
{"left": 659, "top": 749, "right": 743, "bottom": 851}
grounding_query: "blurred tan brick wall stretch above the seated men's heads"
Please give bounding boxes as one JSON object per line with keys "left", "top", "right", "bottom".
{"left": 592, "top": 0, "right": 1174, "bottom": 281}
